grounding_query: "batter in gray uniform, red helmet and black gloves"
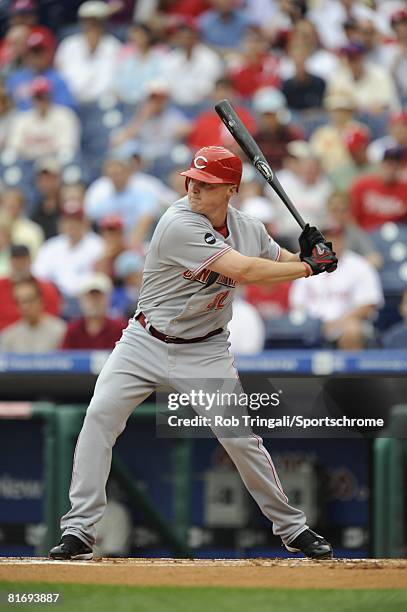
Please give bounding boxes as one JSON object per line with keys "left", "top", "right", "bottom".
{"left": 50, "top": 146, "right": 337, "bottom": 559}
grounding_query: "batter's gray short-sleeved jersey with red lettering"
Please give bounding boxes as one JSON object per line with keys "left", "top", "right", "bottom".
{"left": 138, "top": 197, "right": 280, "bottom": 338}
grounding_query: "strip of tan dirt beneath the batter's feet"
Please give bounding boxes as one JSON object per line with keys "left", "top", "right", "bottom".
{"left": 0, "top": 557, "right": 407, "bottom": 589}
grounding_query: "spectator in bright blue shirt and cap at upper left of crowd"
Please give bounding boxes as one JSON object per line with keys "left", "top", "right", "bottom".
{"left": 6, "top": 28, "right": 77, "bottom": 111}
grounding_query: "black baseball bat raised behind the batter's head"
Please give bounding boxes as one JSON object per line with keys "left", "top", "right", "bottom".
{"left": 215, "top": 100, "right": 305, "bottom": 229}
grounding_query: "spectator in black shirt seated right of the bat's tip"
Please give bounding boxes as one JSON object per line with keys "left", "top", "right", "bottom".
{"left": 282, "top": 44, "right": 325, "bottom": 112}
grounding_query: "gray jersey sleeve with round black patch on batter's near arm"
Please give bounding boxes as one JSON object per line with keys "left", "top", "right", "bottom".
{"left": 158, "top": 214, "right": 232, "bottom": 276}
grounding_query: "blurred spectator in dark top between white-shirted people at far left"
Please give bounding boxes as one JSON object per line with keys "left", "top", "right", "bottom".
{"left": 31, "top": 157, "right": 61, "bottom": 240}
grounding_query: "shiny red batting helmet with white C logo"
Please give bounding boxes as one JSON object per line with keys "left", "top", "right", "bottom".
{"left": 180, "top": 147, "right": 242, "bottom": 188}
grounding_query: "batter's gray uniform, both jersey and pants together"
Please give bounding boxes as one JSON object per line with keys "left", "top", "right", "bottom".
{"left": 57, "top": 198, "right": 307, "bottom": 546}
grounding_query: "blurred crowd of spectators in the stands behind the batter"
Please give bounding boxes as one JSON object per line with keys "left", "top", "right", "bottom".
{"left": 0, "top": 0, "right": 407, "bottom": 353}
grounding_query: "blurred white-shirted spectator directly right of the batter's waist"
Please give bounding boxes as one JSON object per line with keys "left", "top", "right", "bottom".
{"left": 228, "top": 296, "right": 266, "bottom": 355}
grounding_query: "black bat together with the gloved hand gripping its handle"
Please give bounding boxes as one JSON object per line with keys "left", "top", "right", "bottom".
{"left": 215, "top": 100, "right": 337, "bottom": 272}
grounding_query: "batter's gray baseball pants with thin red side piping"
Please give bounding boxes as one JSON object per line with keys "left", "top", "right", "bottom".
{"left": 61, "top": 319, "right": 307, "bottom": 547}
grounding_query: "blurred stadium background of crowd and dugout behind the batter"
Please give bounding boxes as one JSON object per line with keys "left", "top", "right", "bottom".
{"left": 0, "top": 0, "right": 407, "bottom": 557}
